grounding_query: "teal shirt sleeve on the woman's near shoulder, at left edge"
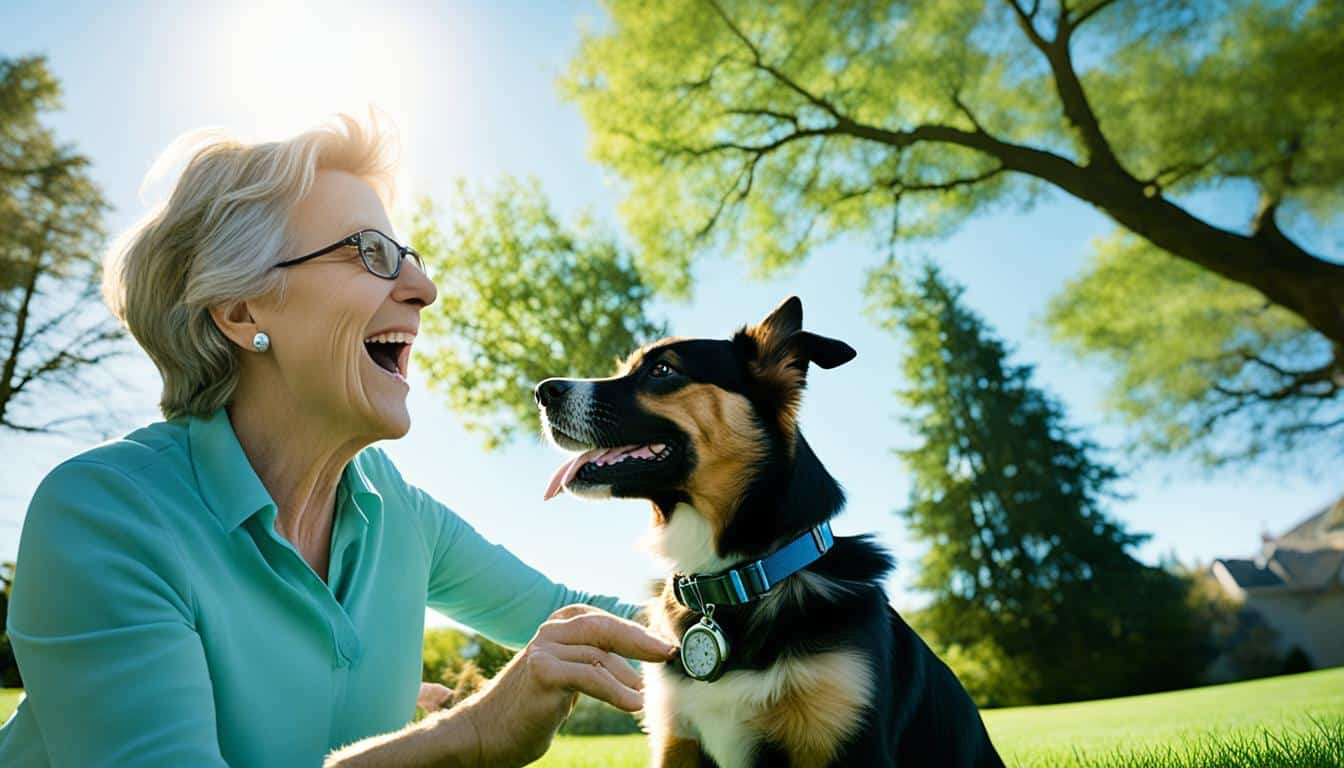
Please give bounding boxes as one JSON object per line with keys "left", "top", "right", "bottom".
{"left": 7, "top": 460, "right": 227, "bottom": 768}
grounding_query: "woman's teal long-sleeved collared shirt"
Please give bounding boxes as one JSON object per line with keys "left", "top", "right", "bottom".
{"left": 0, "top": 409, "right": 634, "bottom": 768}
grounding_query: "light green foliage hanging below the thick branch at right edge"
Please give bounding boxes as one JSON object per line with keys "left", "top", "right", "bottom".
{"left": 1047, "top": 233, "right": 1344, "bottom": 465}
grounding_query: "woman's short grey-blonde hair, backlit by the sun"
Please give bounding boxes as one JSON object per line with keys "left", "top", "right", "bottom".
{"left": 102, "top": 114, "right": 395, "bottom": 418}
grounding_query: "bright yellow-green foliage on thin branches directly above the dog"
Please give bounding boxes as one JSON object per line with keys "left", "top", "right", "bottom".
{"left": 564, "top": 0, "right": 1042, "bottom": 291}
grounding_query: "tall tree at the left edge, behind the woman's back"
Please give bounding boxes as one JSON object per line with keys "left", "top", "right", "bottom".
{"left": 0, "top": 58, "right": 122, "bottom": 432}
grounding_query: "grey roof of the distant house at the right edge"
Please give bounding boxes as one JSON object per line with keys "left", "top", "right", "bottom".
{"left": 1214, "top": 496, "right": 1344, "bottom": 590}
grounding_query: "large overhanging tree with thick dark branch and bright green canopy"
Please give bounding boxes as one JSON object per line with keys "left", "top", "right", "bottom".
{"left": 564, "top": 0, "right": 1344, "bottom": 465}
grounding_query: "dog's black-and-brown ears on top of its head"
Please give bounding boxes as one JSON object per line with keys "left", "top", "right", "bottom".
{"left": 732, "top": 296, "right": 856, "bottom": 434}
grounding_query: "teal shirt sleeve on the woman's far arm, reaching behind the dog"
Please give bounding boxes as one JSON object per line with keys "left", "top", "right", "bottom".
{"left": 379, "top": 457, "right": 640, "bottom": 648}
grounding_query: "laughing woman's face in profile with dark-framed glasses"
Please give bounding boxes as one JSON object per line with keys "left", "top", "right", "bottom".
{"left": 250, "top": 171, "right": 438, "bottom": 440}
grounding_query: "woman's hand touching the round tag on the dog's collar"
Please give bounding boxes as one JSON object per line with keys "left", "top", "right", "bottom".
{"left": 454, "top": 605, "right": 676, "bottom": 765}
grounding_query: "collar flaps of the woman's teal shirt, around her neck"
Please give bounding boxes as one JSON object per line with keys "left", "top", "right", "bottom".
{"left": 187, "top": 408, "right": 383, "bottom": 533}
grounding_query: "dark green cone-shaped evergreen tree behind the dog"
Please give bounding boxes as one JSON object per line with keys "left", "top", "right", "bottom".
{"left": 870, "top": 268, "right": 1207, "bottom": 703}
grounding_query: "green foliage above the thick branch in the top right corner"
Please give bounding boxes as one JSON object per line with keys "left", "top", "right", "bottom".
{"left": 1085, "top": 0, "right": 1344, "bottom": 216}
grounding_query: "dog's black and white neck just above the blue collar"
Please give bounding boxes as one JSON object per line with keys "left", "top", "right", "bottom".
{"left": 648, "top": 433, "right": 844, "bottom": 573}
